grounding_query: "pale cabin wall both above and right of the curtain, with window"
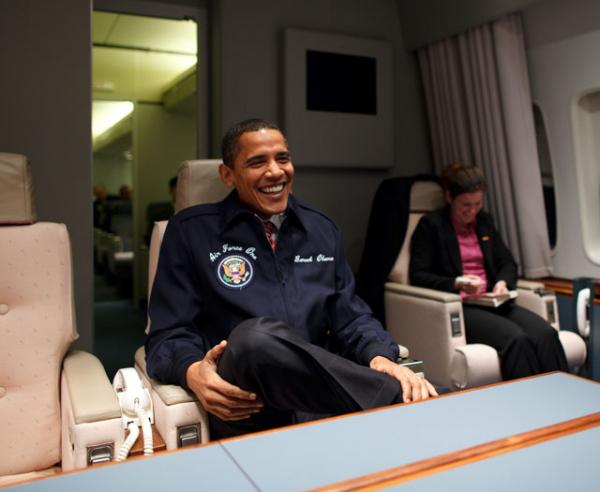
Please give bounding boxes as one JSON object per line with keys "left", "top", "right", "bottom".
{"left": 397, "top": 0, "right": 600, "bottom": 278}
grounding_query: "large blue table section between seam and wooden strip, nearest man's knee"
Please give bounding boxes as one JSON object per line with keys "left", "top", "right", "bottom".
{"left": 223, "top": 373, "right": 600, "bottom": 491}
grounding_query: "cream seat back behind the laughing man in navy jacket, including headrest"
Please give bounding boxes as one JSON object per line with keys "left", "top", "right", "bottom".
{"left": 146, "top": 159, "right": 231, "bottom": 333}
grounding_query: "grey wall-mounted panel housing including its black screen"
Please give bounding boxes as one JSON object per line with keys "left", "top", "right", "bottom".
{"left": 283, "top": 29, "right": 396, "bottom": 169}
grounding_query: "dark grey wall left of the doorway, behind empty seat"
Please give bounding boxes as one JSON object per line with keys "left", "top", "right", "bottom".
{"left": 0, "top": 0, "right": 93, "bottom": 349}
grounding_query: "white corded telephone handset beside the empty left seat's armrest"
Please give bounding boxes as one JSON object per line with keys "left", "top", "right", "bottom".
{"left": 113, "top": 367, "right": 154, "bottom": 461}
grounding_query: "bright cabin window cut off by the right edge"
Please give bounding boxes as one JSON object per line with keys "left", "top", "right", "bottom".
{"left": 571, "top": 89, "right": 600, "bottom": 265}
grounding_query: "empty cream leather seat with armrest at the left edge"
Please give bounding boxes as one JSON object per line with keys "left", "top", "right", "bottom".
{"left": 0, "top": 153, "right": 123, "bottom": 485}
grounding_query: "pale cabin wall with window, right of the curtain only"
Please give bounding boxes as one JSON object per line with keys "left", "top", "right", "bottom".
{"left": 524, "top": 0, "right": 600, "bottom": 278}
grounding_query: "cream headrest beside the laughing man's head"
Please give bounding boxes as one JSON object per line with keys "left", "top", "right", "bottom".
{"left": 175, "top": 159, "right": 231, "bottom": 212}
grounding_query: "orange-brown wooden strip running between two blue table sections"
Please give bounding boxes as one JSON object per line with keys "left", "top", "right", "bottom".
{"left": 314, "top": 412, "right": 600, "bottom": 491}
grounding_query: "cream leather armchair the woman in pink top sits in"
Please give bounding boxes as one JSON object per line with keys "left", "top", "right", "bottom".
{"left": 384, "top": 181, "right": 586, "bottom": 390}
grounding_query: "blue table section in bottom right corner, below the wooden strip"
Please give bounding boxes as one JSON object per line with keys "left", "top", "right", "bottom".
{"left": 386, "top": 427, "right": 600, "bottom": 492}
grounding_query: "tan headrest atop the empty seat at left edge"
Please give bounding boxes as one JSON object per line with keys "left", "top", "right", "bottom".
{"left": 0, "top": 152, "right": 36, "bottom": 224}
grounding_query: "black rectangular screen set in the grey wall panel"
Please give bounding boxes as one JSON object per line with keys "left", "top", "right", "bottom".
{"left": 306, "top": 50, "right": 377, "bottom": 114}
